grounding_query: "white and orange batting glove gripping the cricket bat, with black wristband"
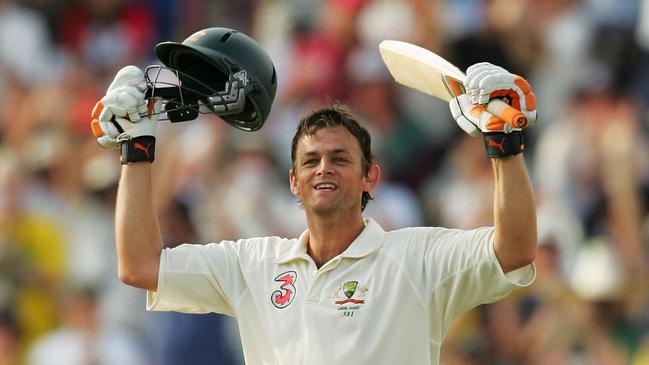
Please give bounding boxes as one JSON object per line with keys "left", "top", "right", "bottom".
{"left": 449, "top": 62, "right": 537, "bottom": 157}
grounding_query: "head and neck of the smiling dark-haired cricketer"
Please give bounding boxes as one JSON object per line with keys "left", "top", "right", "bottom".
{"left": 289, "top": 107, "right": 380, "bottom": 267}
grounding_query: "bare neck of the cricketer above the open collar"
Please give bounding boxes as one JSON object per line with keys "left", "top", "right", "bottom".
{"left": 307, "top": 210, "right": 365, "bottom": 268}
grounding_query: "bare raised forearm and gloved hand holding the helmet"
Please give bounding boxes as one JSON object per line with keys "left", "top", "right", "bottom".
{"left": 91, "top": 66, "right": 162, "bottom": 291}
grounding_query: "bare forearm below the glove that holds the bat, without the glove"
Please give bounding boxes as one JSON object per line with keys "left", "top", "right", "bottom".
{"left": 491, "top": 153, "right": 537, "bottom": 272}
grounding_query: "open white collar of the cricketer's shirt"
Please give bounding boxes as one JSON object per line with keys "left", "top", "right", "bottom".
{"left": 276, "top": 218, "right": 385, "bottom": 264}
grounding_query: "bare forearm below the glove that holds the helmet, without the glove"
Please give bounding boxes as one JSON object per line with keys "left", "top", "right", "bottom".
{"left": 115, "top": 163, "right": 162, "bottom": 291}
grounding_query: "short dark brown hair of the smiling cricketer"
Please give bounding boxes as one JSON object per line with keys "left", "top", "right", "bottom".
{"left": 291, "top": 104, "right": 374, "bottom": 211}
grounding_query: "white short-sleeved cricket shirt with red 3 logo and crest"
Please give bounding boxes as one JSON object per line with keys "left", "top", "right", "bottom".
{"left": 147, "top": 219, "right": 536, "bottom": 365}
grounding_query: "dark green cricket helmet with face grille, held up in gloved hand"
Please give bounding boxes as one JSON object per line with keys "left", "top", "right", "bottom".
{"left": 153, "top": 28, "right": 277, "bottom": 131}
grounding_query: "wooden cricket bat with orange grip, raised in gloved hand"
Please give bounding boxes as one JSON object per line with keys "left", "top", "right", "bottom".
{"left": 379, "top": 40, "right": 527, "bottom": 128}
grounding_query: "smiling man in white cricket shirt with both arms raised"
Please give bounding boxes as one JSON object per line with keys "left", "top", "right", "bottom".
{"left": 91, "top": 58, "right": 536, "bottom": 365}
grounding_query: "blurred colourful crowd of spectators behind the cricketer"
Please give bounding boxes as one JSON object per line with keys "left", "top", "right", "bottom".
{"left": 0, "top": 0, "right": 649, "bottom": 365}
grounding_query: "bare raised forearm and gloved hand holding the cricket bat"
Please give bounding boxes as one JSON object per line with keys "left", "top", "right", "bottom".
{"left": 450, "top": 63, "right": 537, "bottom": 272}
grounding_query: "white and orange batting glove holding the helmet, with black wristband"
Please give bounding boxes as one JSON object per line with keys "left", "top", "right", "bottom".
{"left": 91, "top": 66, "right": 162, "bottom": 163}
